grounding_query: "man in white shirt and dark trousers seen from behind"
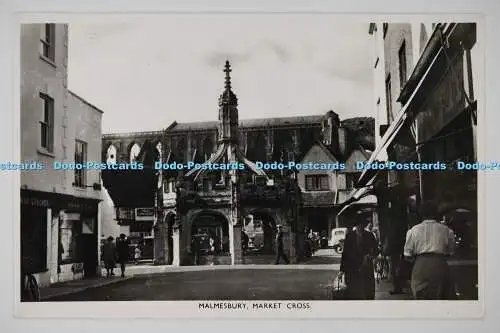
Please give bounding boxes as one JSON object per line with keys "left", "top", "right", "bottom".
{"left": 404, "top": 202, "right": 455, "bottom": 300}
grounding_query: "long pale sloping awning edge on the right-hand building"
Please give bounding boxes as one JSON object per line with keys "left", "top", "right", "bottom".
{"left": 357, "top": 24, "right": 454, "bottom": 187}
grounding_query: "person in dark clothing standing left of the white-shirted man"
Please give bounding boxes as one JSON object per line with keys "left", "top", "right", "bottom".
{"left": 339, "top": 215, "right": 378, "bottom": 300}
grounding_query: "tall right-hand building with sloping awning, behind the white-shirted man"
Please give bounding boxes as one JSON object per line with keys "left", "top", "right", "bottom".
{"left": 354, "top": 23, "right": 481, "bottom": 298}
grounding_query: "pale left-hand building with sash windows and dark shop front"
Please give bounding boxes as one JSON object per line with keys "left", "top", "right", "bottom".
{"left": 20, "top": 24, "right": 102, "bottom": 285}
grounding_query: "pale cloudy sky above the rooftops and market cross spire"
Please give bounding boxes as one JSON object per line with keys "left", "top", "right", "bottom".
{"left": 68, "top": 14, "right": 373, "bottom": 133}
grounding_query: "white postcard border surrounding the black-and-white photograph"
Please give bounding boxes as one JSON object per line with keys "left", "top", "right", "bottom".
{"left": 12, "top": 9, "right": 487, "bottom": 319}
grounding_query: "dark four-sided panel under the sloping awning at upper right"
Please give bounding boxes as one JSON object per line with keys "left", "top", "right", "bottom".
{"left": 416, "top": 54, "right": 465, "bottom": 142}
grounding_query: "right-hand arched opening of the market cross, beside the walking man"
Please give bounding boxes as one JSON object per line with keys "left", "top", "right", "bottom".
{"left": 243, "top": 209, "right": 280, "bottom": 253}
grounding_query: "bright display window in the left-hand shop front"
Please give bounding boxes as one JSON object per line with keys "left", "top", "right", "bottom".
{"left": 59, "top": 213, "right": 82, "bottom": 264}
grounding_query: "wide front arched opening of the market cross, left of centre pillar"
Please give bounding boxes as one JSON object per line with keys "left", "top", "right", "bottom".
{"left": 187, "top": 209, "right": 230, "bottom": 254}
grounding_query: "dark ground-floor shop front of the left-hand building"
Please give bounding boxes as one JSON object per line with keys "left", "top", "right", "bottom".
{"left": 21, "top": 190, "right": 99, "bottom": 285}
